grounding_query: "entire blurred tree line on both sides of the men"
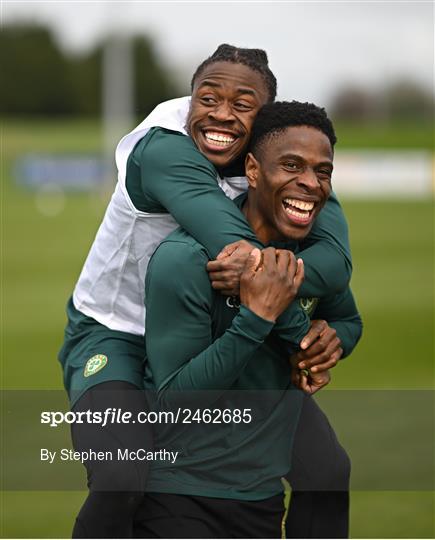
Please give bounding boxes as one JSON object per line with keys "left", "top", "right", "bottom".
{"left": 0, "top": 25, "right": 434, "bottom": 123}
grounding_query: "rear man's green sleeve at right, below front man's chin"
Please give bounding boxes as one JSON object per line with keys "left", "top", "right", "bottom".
{"left": 298, "top": 193, "right": 352, "bottom": 298}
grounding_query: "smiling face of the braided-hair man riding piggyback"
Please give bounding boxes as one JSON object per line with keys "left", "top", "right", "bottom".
{"left": 187, "top": 62, "right": 268, "bottom": 167}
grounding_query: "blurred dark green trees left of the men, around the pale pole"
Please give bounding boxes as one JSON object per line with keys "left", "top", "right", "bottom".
{"left": 0, "top": 25, "right": 180, "bottom": 117}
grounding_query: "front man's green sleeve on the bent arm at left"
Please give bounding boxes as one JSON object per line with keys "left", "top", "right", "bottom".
{"left": 145, "top": 241, "right": 273, "bottom": 407}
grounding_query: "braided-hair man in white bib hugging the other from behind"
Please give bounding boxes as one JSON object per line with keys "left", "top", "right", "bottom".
{"left": 59, "top": 45, "right": 358, "bottom": 538}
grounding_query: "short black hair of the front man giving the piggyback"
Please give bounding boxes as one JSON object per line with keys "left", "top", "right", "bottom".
{"left": 249, "top": 101, "right": 337, "bottom": 155}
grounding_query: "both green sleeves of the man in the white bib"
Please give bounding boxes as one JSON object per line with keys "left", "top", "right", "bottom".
{"left": 126, "top": 128, "right": 352, "bottom": 298}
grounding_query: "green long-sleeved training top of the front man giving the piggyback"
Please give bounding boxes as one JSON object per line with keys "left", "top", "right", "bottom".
{"left": 145, "top": 200, "right": 361, "bottom": 500}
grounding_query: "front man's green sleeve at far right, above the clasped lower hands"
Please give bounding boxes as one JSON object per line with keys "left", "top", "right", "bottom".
{"left": 312, "top": 287, "right": 362, "bottom": 358}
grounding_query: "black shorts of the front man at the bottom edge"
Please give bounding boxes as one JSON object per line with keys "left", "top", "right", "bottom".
{"left": 133, "top": 493, "right": 285, "bottom": 538}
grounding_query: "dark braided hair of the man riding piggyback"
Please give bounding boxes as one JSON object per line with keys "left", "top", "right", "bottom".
{"left": 190, "top": 43, "right": 276, "bottom": 101}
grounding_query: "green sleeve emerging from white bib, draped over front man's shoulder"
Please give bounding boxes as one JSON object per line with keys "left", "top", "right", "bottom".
{"left": 134, "top": 129, "right": 263, "bottom": 259}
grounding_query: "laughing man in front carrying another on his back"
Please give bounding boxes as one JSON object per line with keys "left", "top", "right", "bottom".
{"left": 136, "top": 102, "right": 361, "bottom": 538}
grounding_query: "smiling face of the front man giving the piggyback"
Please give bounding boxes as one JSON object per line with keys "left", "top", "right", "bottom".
{"left": 245, "top": 126, "right": 333, "bottom": 244}
